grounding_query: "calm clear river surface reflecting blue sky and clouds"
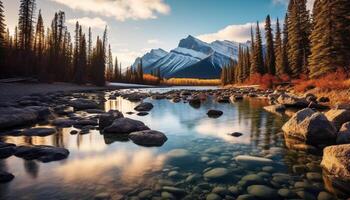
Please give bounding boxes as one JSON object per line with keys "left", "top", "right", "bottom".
{"left": 0, "top": 88, "right": 344, "bottom": 200}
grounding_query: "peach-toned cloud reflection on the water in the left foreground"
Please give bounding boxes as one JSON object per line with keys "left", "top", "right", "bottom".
{"left": 56, "top": 148, "right": 166, "bottom": 183}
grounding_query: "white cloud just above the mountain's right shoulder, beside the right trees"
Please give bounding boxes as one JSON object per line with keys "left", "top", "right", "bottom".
{"left": 197, "top": 23, "right": 263, "bottom": 43}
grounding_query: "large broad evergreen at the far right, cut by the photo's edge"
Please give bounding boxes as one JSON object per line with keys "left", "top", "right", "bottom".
{"left": 309, "top": 0, "right": 350, "bottom": 78}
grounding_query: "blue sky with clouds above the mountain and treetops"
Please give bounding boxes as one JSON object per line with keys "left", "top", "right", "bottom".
{"left": 3, "top": 0, "right": 314, "bottom": 66}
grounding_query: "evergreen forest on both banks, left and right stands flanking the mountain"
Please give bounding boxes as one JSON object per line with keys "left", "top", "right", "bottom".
{"left": 0, "top": 0, "right": 350, "bottom": 86}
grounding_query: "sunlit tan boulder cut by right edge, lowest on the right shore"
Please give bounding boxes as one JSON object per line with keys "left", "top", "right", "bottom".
{"left": 321, "top": 144, "right": 350, "bottom": 180}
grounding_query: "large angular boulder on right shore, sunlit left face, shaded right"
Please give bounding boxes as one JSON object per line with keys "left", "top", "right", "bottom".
{"left": 282, "top": 108, "right": 336, "bottom": 146}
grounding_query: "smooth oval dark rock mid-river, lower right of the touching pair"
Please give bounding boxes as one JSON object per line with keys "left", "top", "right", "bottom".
{"left": 129, "top": 130, "right": 168, "bottom": 147}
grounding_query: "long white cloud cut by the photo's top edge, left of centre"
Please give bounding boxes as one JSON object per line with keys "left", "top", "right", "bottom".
{"left": 51, "top": 0, "right": 170, "bottom": 21}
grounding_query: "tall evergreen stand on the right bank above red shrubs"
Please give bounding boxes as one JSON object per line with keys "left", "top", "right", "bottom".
{"left": 221, "top": 0, "right": 350, "bottom": 85}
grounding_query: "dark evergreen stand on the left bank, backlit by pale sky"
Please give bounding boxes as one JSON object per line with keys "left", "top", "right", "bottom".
{"left": 0, "top": 0, "right": 150, "bottom": 86}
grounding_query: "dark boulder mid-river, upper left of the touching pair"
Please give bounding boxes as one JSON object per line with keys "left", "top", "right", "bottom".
{"left": 103, "top": 118, "right": 149, "bottom": 134}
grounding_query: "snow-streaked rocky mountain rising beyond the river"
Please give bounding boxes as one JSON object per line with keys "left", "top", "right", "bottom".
{"left": 133, "top": 35, "right": 248, "bottom": 78}
